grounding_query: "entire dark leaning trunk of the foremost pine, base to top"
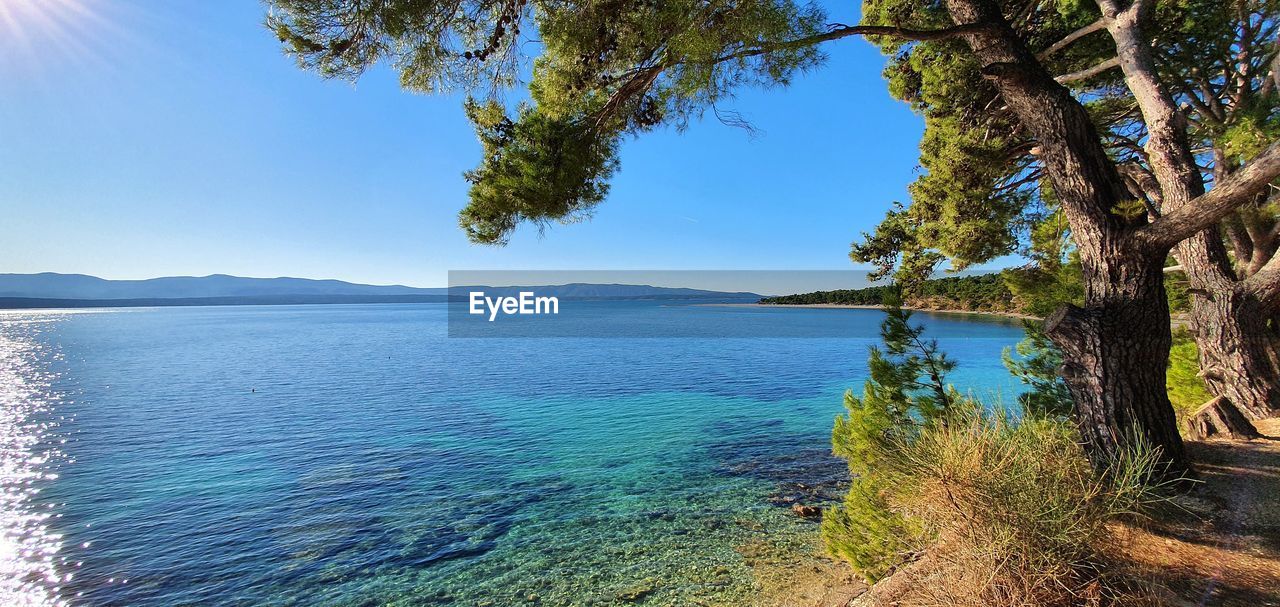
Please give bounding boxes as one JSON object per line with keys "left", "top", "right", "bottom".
{"left": 946, "top": 0, "right": 1188, "bottom": 476}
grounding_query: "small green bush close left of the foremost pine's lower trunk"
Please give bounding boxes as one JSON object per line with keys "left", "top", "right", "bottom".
{"left": 1002, "top": 321, "right": 1071, "bottom": 419}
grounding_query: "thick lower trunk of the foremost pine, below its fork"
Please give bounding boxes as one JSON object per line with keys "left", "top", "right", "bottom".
{"left": 1044, "top": 247, "right": 1188, "bottom": 478}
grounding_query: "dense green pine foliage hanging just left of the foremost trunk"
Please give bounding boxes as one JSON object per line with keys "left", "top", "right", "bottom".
{"left": 850, "top": 0, "right": 1114, "bottom": 280}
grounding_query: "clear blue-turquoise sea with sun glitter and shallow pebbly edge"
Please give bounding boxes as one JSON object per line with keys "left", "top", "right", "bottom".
{"left": 0, "top": 305, "right": 1021, "bottom": 606}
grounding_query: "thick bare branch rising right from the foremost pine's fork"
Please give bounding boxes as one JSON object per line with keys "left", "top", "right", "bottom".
{"left": 1135, "top": 141, "right": 1280, "bottom": 247}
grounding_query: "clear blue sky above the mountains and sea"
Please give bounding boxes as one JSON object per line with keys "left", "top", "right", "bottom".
{"left": 0, "top": 0, "right": 1008, "bottom": 286}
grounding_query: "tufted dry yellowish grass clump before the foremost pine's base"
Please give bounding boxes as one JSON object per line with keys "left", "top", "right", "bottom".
{"left": 880, "top": 415, "right": 1177, "bottom": 607}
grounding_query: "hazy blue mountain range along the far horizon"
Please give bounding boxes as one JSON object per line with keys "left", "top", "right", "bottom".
{"left": 0, "top": 273, "right": 760, "bottom": 309}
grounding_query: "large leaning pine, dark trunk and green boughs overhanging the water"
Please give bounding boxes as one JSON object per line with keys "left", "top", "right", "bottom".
{"left": 268, "top": 0, "right": 1280, "bottom": 473}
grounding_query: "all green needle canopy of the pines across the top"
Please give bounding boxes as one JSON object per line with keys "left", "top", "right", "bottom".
{"left": 266, "top": 0, "right": 1280, "bottom": 256}
